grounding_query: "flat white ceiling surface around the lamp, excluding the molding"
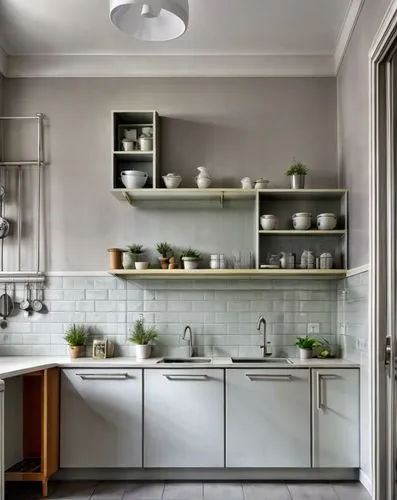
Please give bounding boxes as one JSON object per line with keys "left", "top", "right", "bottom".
{"left": 0, "top": 0, "right": 350, "bottom": 55}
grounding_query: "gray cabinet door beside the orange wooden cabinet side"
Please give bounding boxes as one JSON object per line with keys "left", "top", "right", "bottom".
{"left": 61, "top": 368, "right": 142, "bottom": 467}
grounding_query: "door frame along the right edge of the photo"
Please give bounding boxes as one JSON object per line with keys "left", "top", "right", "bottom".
{"left": 369, "top": 0, "right": 397, "bottom": 500}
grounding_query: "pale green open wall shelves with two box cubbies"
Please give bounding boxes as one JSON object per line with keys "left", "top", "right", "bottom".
{"left": 109, "top": 111, "right": 348, "bottom": 279}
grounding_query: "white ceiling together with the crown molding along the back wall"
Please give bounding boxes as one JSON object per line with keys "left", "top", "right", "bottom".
{"left": 0, "top": 0, "right": 364, "bottom": 77}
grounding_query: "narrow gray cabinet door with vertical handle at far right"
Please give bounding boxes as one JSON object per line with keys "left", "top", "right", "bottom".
{"left": 312, "top": 368, "right": 360, "bottom": 467}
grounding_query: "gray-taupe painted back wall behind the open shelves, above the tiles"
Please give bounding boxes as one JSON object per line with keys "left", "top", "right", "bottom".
{"left": 5, "top": 78, "right": 337, "bottom": 271}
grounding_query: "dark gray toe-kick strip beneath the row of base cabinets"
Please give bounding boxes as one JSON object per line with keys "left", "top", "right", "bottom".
{"left": 55, "top": 468, "right": 359, "bottom": 481}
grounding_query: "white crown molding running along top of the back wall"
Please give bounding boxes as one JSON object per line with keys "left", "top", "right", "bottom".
{"left": 6, "top": 54, "right": 335, "bottom": 78}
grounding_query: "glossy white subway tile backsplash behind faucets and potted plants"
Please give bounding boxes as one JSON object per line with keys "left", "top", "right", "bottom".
{"left": 0, "top": 276, "right": 340, "bottom": 356}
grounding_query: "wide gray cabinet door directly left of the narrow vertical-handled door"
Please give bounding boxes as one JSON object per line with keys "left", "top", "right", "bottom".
{"left": 226, "top": 369, "right": 311, "bottom": 467}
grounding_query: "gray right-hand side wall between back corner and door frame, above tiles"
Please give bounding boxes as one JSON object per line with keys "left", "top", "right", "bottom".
{"left": 337, "top": 0, "right": 389, "bottom": 268}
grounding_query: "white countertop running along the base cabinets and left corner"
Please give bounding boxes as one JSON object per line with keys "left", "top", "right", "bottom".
{"left": 0, "top": 356, "right": 360, "bottom": 379}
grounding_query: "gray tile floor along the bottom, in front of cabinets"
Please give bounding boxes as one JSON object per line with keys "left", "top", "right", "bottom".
{"left": 6, "top": 481, "right": 370, "bottom": 500}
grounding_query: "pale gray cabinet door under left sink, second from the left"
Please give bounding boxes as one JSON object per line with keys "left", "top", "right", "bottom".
{"left": 144, "top": 369, "right": 224, "bottom": 467}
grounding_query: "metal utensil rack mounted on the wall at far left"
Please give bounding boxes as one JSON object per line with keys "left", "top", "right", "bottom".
{"left": 0, "top": 113, "right": 45, "bottom": 283}
